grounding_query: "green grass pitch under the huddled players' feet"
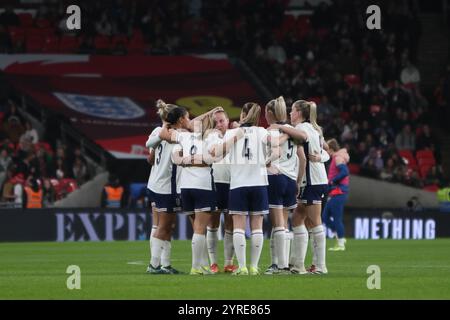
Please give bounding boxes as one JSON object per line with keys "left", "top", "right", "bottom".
{"left": 0, "top": 239, "right": 450, "bottom": 300}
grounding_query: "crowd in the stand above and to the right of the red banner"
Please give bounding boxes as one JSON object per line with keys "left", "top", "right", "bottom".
{"left": 0, "top": 0, "right": 450, "bottom": 190}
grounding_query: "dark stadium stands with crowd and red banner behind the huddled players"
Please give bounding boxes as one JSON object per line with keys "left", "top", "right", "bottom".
{"left": 0, "top": 0, "right": 450, "bottom": 240}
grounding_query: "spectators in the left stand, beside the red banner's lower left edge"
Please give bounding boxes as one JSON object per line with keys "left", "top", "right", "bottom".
{"left": 0, "top": 100, "right": 91, "bottom": 208}
